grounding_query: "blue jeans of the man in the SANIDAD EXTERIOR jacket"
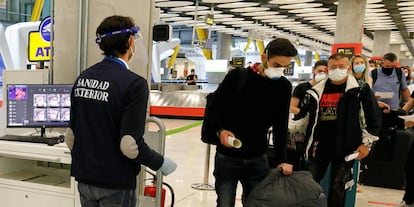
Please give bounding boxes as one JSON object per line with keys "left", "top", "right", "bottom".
{"left": 78, "top": 183, "right": 137, "bottom": 207}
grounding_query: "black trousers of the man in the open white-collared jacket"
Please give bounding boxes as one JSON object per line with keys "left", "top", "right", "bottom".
{"left": 307, "top": 157, "right": 354, "bottom": 207}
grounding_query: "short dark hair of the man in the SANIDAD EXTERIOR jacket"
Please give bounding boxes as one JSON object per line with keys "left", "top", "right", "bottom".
{"left": 96, "top": 15, "right": 135, "bottom": 56}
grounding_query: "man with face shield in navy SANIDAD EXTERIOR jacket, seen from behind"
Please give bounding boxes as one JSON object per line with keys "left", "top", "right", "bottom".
{"left": 65, "top": 16, "right": 176, "bottom": 207}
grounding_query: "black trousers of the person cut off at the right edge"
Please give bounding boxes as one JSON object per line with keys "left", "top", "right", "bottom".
{"left": 403, "top": 142, "right": 414, "bottom": 204}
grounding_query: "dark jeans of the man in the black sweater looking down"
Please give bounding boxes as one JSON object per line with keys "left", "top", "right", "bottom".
{"left": 213, "top": 152, "right": 270, "bottom": 207}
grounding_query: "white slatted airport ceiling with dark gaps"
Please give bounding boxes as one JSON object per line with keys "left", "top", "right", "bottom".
{"left": 155, "top": 0, "right": 414, "bottom": 58}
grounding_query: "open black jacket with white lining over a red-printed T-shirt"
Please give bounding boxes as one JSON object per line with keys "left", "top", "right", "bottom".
{"left": 289, "top": 75, "right": 381, "bottom": 160}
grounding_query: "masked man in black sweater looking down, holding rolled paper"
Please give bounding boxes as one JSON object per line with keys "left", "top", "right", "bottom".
{"left": 209, "top": 38, "right": 297, "bottom": 207}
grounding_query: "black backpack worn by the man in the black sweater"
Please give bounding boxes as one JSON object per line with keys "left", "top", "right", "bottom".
{"left": 201, "top": 68, "right": 248, "bottom": 145}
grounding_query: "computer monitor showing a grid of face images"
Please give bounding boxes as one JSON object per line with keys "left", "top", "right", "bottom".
{"left": 6, "top": 84, "right": 72, "bottom": 137}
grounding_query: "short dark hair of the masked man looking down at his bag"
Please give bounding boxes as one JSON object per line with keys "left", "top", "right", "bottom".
{"left": 264, "top": 38, "right": 298, "bottom": 59}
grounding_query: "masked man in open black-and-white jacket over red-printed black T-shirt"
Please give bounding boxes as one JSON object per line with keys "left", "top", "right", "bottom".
{"left": 289, "top": 54, "right": 381, "bottom": 207}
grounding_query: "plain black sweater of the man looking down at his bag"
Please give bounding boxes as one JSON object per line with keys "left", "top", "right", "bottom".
{"left": 209, "top": 69, "right": 292, "bottom": 166}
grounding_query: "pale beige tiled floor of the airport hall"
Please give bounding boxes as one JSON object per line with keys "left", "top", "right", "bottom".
{"left": 146, "top": 119, "right": 404, "bottom": 207}
